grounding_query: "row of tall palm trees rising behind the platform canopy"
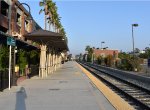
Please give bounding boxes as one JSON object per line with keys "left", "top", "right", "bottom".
{"left": 39, "top": 0, "right": 67, "bottom": 42}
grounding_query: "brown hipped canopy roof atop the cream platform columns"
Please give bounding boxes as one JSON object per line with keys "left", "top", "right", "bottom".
{"left": 24, "top": 29, "right": 69, "bottom": 51}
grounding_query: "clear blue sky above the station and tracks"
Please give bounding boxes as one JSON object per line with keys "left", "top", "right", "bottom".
{"left": 19, "top": 0, "right": 150, "bottom": 55}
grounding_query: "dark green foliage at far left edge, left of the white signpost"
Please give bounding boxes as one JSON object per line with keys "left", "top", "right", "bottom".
{"left": 0, "top": 45, "right": 9, "bottom": 70}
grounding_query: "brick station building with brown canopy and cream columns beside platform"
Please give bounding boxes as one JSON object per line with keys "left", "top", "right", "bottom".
{"left": 0, "top": 0, "right": 69, "bottom": 88}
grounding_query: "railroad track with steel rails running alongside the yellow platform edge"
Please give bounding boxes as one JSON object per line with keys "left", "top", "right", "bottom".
{"left": 79, "top": 63, "right": 150, "bottom": 110}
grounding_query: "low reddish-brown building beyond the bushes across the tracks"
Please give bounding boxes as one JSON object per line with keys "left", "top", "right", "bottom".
{"left": 94, "top": 49, "right": 119, "bottom": 58}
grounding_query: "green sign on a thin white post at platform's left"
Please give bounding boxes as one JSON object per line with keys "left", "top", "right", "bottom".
{"left": 7, "top": 37, "right": 16, "bottom": 90}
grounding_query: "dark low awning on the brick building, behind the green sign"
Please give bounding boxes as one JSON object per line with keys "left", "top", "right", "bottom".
{"left": 0, "top": 31, "right": 39, "bottom": 51}
